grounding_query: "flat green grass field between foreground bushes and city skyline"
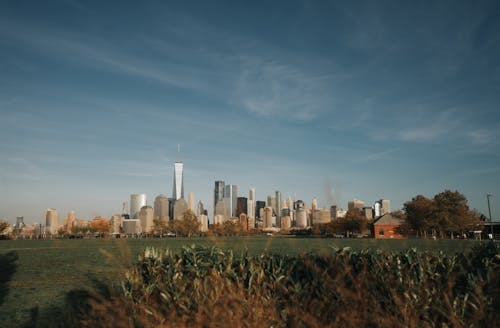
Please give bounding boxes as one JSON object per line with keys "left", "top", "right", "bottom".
{"left": 0, "top": 237, "right": 488, "bottom": 327}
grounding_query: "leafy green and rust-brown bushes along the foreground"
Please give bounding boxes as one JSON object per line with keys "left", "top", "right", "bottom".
{"left": 72, "top": 243, "right": 500, "bottom": 327}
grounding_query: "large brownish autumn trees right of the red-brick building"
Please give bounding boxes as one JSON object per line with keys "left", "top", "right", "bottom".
{"left": 404, "top": 190, "right": 480, "bottom": 237}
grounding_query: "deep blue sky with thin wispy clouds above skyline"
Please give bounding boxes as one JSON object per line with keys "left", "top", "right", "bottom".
{"left": 0, "top": 0, "right": 500, "bottom": 223}
